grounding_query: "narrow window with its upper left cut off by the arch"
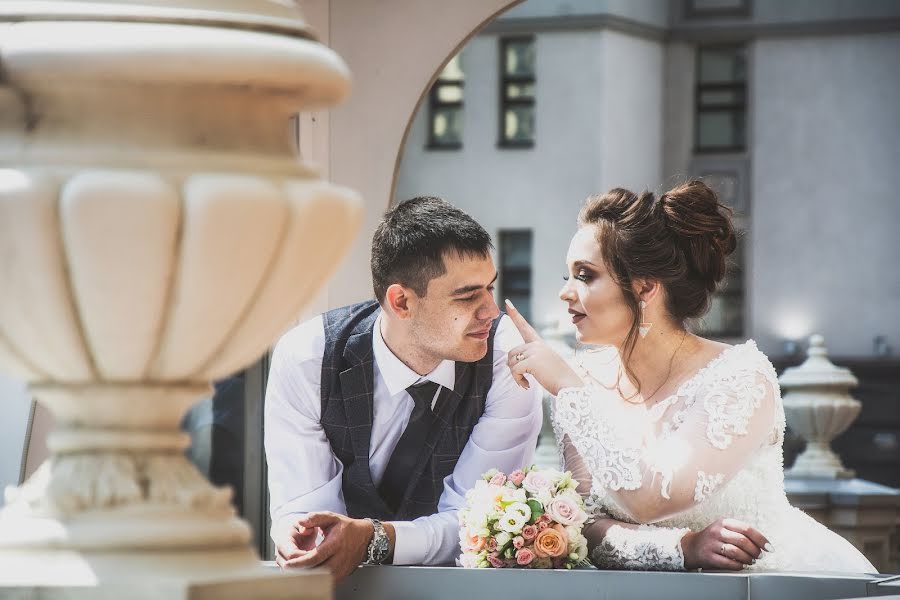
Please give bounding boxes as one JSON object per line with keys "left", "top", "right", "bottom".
{"left": 428, "top": 54, "right": 464, "bottom": 150}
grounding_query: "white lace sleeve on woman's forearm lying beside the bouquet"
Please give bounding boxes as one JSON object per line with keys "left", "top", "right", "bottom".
{"left": 590, "top": 524, "right": 690, "bottom": 571}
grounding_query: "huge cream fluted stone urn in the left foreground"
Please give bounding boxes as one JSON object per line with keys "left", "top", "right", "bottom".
{"left": 0, "top": 0, "right": 362, "bottom": 598}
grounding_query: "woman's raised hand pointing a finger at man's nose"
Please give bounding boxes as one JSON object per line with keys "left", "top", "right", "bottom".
{"left": 506, "top": 300, "right": 584, "bottom": 396}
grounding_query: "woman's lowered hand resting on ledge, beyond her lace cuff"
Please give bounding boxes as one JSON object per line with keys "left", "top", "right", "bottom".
{"left": 681, "top": 519, "right": 772, "bottom": 571}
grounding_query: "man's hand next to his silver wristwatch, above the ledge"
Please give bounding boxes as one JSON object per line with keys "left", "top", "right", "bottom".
{"left": 283, "top": 512, "right": 387, "bottom": 581}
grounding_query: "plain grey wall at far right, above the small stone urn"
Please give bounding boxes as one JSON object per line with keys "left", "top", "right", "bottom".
{"left": 749, "top": 33, "right": 900, "bottom": 355}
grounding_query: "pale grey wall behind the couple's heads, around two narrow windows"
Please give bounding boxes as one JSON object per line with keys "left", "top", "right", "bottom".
{"left": 395, "top": 31, "right": 663, "bottom": 322}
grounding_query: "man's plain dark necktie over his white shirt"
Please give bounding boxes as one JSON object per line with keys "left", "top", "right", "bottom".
{"left": 378, "top": 381, "right": 439, "bottom": 512}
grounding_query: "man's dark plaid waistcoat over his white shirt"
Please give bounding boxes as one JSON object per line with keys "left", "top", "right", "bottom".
{"left": 321, "top": 301, "right": 500, "bottom": 521}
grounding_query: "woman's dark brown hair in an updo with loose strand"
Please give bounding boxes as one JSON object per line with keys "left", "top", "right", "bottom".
{"left": 578, "top": 180, "right": 737, "bottom": 389}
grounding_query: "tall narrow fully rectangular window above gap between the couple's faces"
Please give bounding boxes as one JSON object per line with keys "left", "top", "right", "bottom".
{"left": 498, "top": 37, "right": 534, "bottom": 148}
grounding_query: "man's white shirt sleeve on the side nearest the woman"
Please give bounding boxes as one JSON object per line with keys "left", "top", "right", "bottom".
{"left": 392, "top": 315, "right": 543, "bottom": 565}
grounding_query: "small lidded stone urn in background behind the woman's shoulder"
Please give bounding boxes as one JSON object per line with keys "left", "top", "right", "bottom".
{"left": 778, "top": 335, "right": 862, "bottom": 479}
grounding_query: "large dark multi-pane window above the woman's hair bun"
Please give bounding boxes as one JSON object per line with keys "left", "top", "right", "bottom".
{"left": 694, "top": 45, "right": 747, "bottom": 152}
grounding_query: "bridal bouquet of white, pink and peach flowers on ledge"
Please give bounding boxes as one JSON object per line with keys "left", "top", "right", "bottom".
{"left": 459, "top": 467, "right": 588, "bottom": 569}
